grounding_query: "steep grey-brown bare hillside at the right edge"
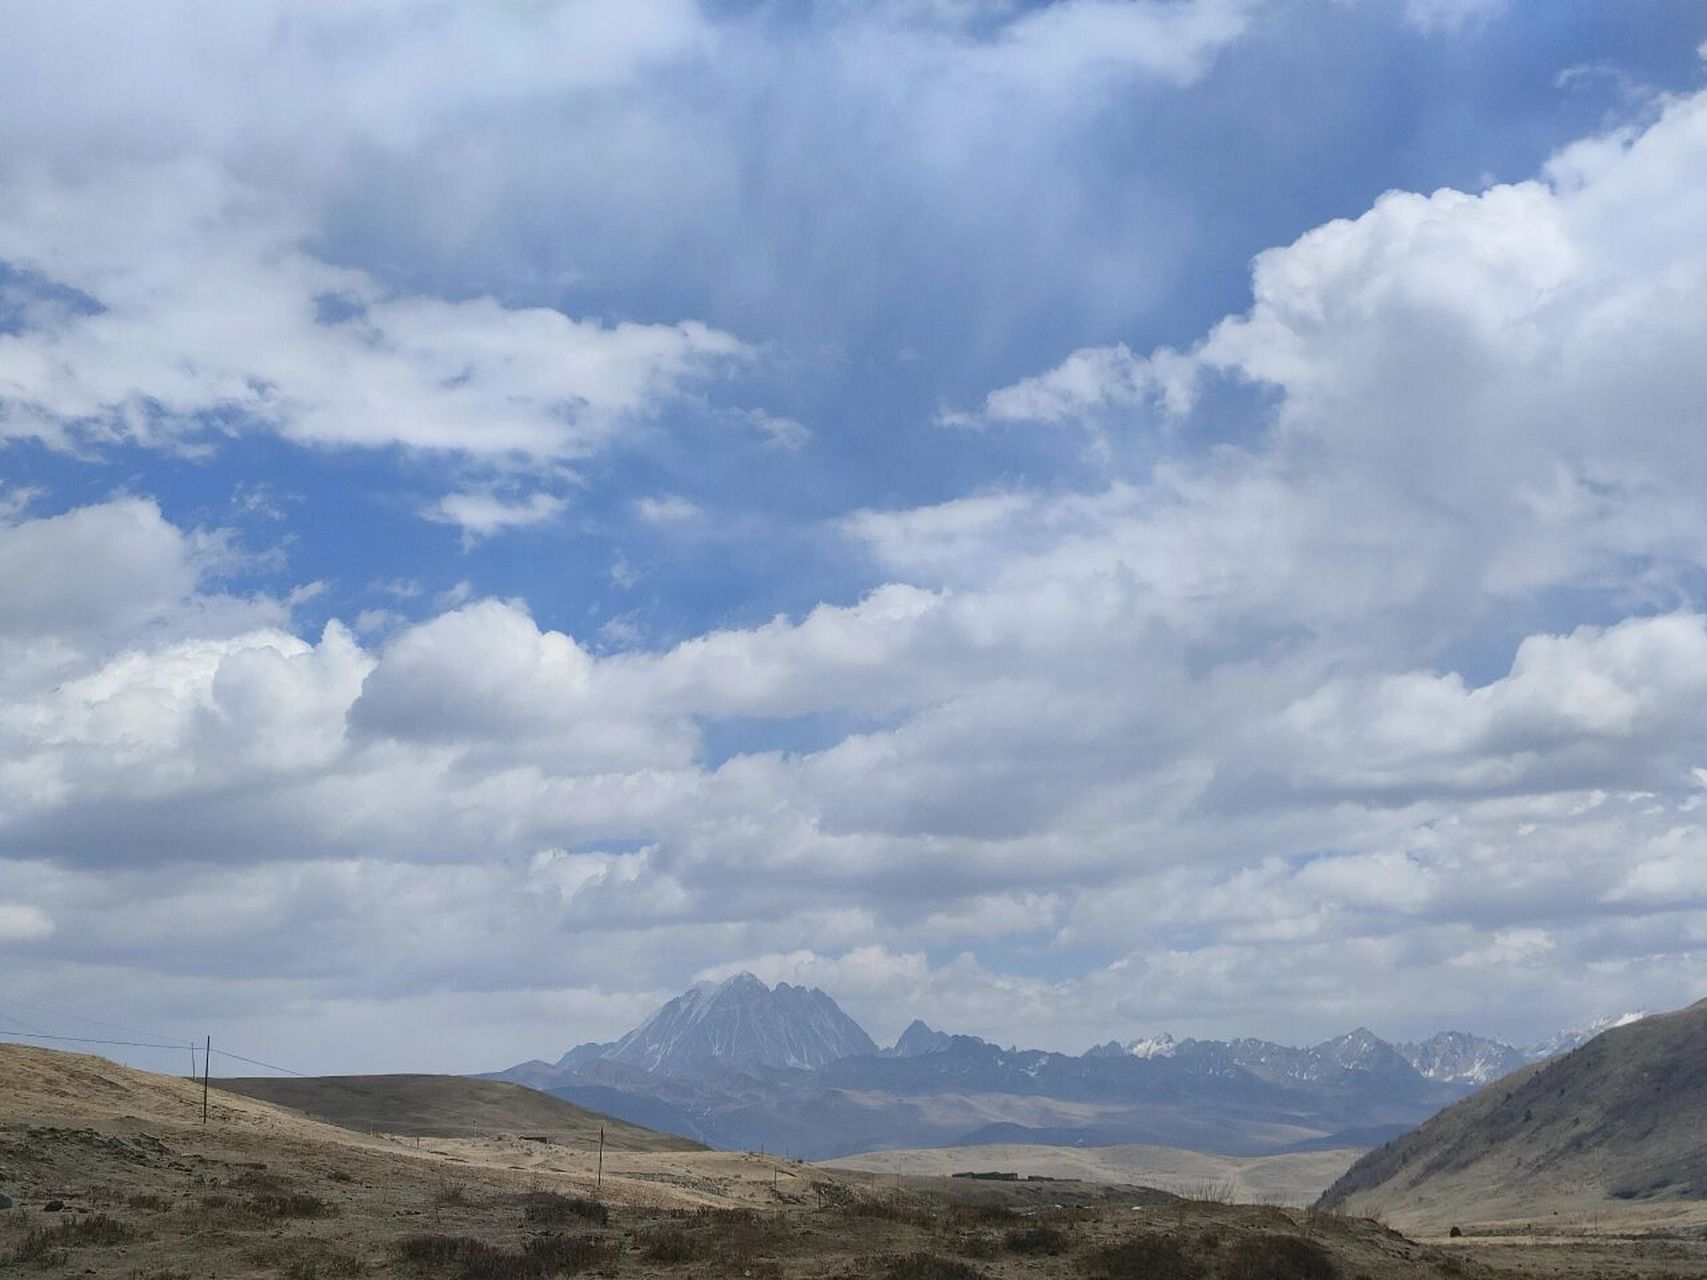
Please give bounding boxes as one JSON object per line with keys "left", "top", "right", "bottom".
{"left": 1321, "top": 1000, "right": 1707, "bottom": 1231}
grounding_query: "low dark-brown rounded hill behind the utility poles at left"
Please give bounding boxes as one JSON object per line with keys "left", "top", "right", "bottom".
{"left": 213, "top": 1075, "right": 705, "bottom": 1150}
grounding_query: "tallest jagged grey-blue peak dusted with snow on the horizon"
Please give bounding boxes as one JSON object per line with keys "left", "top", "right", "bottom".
{"left": 599, "top": 973, "right": 877, "bottom": 1075}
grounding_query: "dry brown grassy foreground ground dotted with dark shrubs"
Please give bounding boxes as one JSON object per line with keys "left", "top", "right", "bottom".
{"left": 0, "top": 1046, "right": 1707, "bottom": 1280}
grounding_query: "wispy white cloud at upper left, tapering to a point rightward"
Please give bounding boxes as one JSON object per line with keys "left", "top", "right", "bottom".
{"left": 0, "top": 160, "right": 746, "bottom": 467}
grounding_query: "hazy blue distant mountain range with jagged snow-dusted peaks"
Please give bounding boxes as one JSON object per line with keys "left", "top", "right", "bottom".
{"left": 490, "top": 973, "right": 1638, "bottom": 1159}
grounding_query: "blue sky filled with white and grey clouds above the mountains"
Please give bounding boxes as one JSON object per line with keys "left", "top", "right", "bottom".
{"left": 0, "top": 0, "right": 1707, "bottom": 1072}
